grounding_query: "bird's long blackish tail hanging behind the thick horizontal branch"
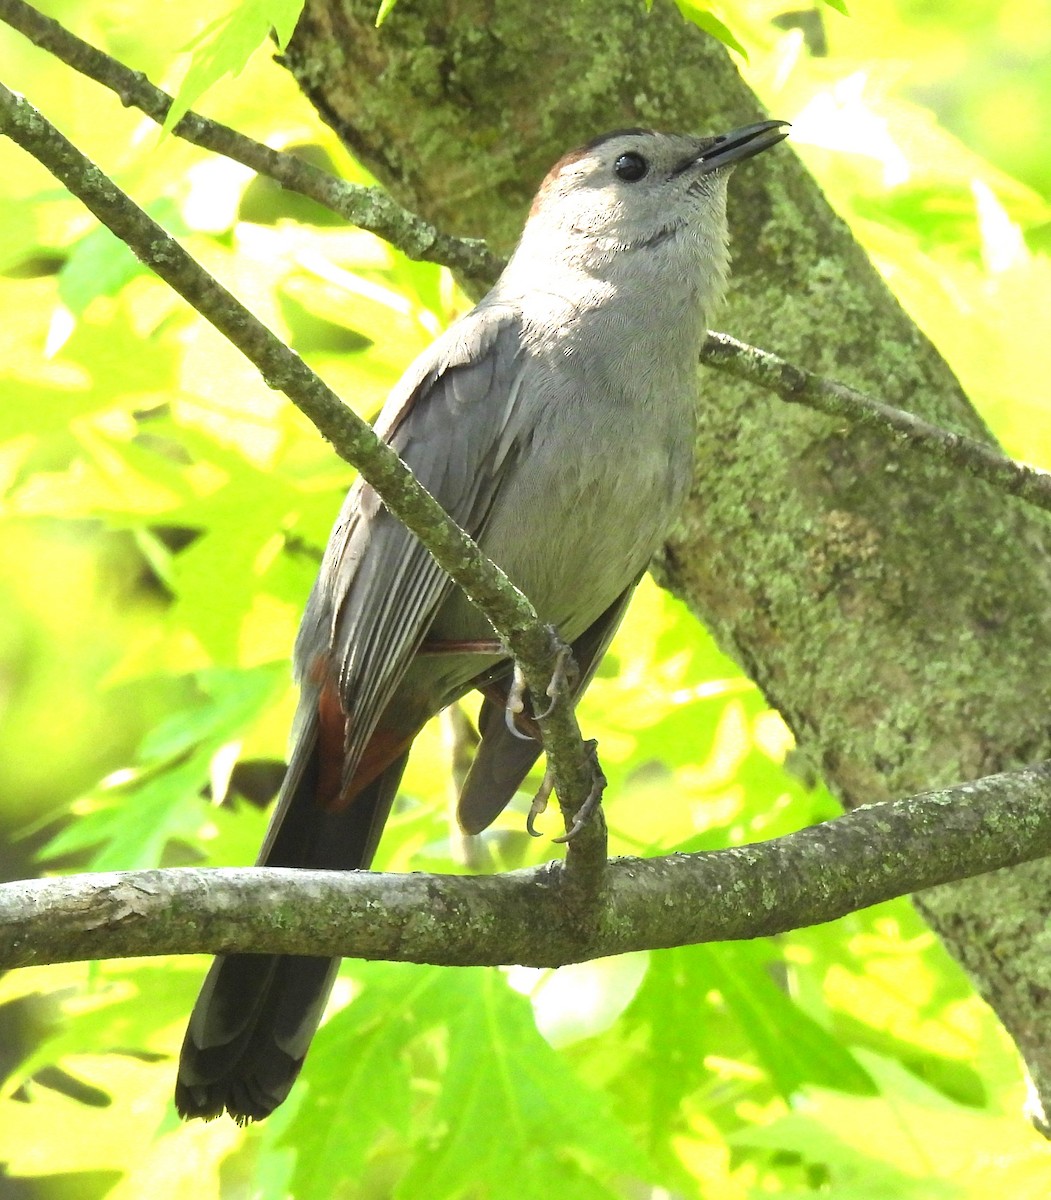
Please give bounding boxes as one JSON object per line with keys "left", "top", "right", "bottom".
{"left": 175, "top": 739, "right": 408, "bottom": 1124}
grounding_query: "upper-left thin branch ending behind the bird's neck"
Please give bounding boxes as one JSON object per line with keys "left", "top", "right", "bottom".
{"left": 0, "top": 0, "right": 503, "bottom": 294}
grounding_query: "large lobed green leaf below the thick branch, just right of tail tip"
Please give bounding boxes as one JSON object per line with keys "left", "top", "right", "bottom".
{"left": 288, "top": 964, "right": 654, "bottom": 1200}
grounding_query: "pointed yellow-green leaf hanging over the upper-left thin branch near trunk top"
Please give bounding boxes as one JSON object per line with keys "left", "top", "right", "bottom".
{"left": 164, "top": 0, "right": 304, "bottom": 132}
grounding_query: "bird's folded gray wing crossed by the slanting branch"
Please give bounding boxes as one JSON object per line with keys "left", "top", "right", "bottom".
{"left": 294, "top": 306, "right": 523, "bottom": 782}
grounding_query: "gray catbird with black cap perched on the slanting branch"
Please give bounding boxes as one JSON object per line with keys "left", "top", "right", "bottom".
{"left": 175, "top": 121, "right": 786, "bottom": 1121}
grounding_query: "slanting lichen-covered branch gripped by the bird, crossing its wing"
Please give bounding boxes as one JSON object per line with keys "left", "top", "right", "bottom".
{"left": 0, "top": 84, "right": 606, "bottom": 873}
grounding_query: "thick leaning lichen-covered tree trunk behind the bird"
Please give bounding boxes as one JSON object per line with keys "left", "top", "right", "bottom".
{"left": 279, "top": 0, "right": 1051, "bottom": 1123}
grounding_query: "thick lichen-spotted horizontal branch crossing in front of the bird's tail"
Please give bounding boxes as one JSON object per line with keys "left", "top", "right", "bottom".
{"left": 0, "top": 763, "right": 1051, "bottom": 970}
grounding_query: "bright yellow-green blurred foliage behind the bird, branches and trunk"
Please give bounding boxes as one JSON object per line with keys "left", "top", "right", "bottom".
{"left": 0, "top": 0, "right": 1051, "bottom": 1200}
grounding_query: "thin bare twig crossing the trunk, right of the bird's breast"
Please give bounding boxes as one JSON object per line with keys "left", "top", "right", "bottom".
{"left": 701, "top": 332, "right": 1051, "bottom": 511}
